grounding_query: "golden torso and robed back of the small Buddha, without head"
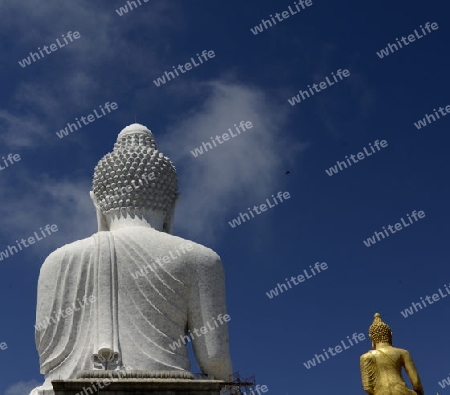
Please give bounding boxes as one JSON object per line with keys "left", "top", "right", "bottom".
{"left": 360, "top": 350, "right": 416, "bottom": 395}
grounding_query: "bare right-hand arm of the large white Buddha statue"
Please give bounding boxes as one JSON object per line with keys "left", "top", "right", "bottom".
{"left": 188, "top": 249, "right": 233, "bottom": 381}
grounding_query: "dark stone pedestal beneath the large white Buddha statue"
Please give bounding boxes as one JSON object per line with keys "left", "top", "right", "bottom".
{"left": 52, "top": 378, "right": 225, "bottom": 395}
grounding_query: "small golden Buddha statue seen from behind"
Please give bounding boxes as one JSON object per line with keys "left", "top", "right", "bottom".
{"left": 360, "top": 313, "right": 423, "bottom": 395}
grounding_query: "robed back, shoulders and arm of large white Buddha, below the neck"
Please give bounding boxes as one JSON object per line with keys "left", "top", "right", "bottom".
{"left": 31, "top": 227, "right": 231, "bottom": 395}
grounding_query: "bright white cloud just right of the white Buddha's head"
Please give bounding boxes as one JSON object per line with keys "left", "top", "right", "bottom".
{"left": 155, "top": 81, "right": 306, "bottom": 239}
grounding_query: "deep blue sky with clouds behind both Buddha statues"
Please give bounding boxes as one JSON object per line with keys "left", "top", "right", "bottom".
{"left": 0, "top": 0, "right": 450, "bottom": 395}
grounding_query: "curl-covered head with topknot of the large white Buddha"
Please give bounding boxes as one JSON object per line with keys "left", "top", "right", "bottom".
{"left": 92, "top": 123, "right": 178, "bottom": 217}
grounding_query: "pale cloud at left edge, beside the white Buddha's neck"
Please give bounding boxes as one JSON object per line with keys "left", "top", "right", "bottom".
{"left": 0, "top": 169, "right": 97, "bottom": 253}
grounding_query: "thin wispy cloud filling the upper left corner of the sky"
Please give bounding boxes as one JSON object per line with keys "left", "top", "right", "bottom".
{"left": 0, "top": 0, "right": 178, "bottom": 148}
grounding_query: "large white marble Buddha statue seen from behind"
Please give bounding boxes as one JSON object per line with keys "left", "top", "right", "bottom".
{"left": 30, "top": 124, "right": 232, "bottom": 395}
